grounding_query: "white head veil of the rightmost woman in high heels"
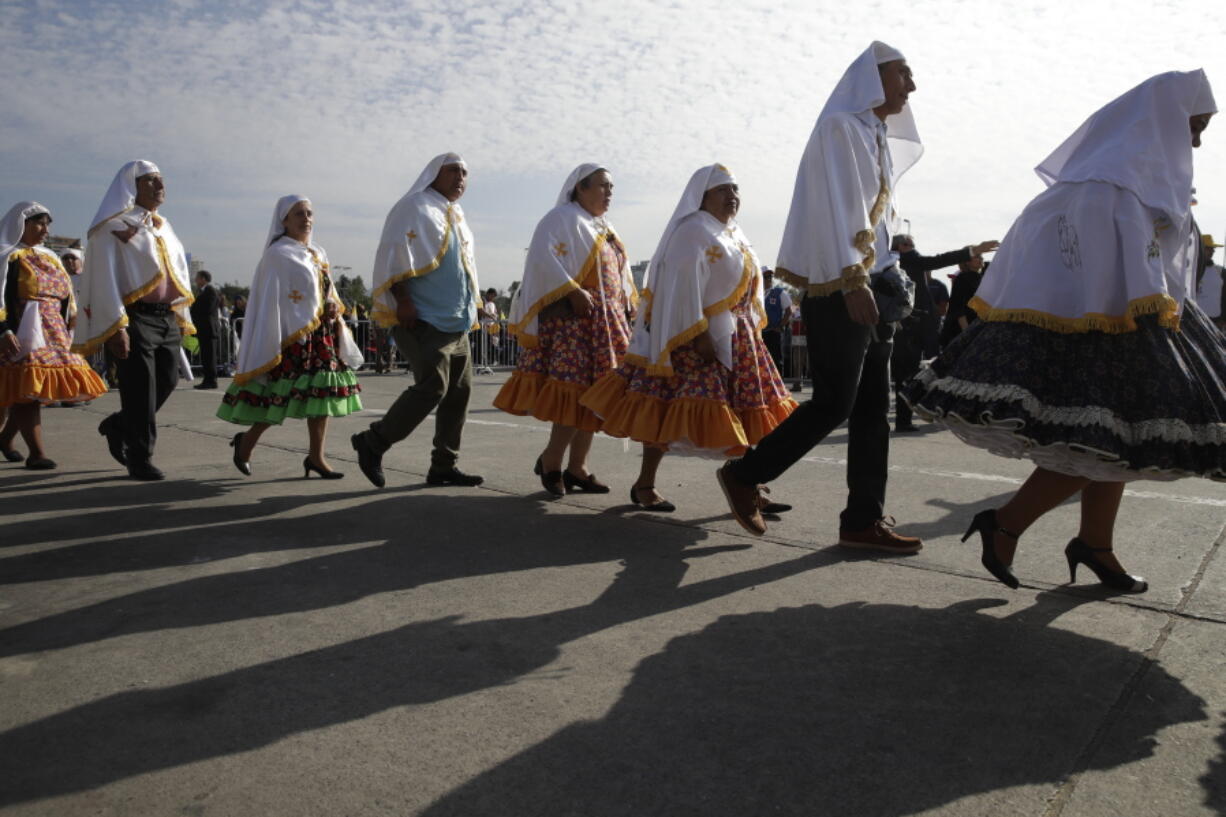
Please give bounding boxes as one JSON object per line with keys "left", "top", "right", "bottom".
{"left": 1035, "top": 69, "right": 1217, "bottom": 224}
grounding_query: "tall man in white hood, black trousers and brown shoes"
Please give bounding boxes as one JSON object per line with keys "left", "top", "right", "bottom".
{"left": 718, "top": 42, "right": 923, "bottom": 553}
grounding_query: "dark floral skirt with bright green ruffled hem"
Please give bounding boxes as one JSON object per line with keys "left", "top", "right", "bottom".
{"left": 217, "top": 328, "right": 362, "bottom": 426}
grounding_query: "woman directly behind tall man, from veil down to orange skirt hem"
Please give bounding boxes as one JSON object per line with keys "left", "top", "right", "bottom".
{"left": 582, "top": 164, "right": 796, "bottom": 473}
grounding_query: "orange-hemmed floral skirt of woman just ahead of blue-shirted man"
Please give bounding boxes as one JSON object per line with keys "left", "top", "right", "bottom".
{"left": 494, "top": 301, "right": 630, "bottom": 432}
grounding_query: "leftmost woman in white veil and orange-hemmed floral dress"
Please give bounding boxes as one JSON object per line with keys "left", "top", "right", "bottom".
{"left": 0, "top": 201, "right": 107, "bottom": 470}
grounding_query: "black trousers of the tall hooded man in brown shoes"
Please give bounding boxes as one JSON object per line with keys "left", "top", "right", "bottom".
{"left": 732, "top": 292, "right": 894, "bottom": 530}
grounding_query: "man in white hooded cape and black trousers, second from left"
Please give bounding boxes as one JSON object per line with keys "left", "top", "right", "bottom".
{"left": 72, "top": 161, "right": 196, "bottom": 480}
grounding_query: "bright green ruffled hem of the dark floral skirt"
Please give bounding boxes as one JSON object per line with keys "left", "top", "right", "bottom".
{"left": 217, "top": 369, "right": 362, "bottom": 426}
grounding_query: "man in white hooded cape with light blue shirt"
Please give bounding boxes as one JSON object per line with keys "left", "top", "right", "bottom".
{"left": 352, "top": 153, "right": 483, "bottom": 488}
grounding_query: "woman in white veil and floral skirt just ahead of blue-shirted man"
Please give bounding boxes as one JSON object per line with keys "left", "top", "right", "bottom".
{"left": 494, "top": 163, "right": 642, "bottom": 497}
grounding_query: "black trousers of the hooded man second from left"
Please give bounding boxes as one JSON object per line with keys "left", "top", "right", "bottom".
{"left": 104, "top": 309, "right": 180, "bottom": 465}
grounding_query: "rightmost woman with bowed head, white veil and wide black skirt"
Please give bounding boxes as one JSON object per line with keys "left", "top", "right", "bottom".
{"left": 906, "top": 71, "right": 1226, "bottom": 593}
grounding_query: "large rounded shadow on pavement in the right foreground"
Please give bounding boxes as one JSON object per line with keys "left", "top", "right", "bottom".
{"left": 423, "top": 597, "right": 1206, "bottom": 817}
